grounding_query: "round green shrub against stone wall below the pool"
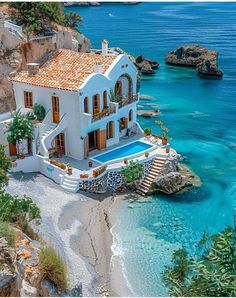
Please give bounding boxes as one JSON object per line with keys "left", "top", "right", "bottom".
{"left": 121, "top": 160, "right": 144, "bottom": 183}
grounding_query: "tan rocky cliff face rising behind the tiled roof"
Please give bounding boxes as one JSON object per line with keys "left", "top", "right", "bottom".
{"left": 0, "top": 26, "right": 90, "bottom": 113}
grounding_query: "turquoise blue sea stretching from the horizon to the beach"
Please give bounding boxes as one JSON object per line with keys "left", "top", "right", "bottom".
{"left": 65, "top": 3, "right": 236, "bottom": 296}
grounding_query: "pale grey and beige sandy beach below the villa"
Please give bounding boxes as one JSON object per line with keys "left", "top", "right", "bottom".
{"left": 6, "top": 173, "right": 133, "bottom": 296}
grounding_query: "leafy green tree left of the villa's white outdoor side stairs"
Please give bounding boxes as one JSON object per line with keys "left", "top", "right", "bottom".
{"left": 7, "top": 110, "right": 34, "bottom": 153}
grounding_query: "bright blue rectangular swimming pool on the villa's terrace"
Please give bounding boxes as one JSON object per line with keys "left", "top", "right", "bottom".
{"left": 93, "top": 141, "right": 153, "bottom": 163}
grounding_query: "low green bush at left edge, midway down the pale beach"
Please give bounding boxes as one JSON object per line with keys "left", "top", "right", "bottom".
{"left": 0, "top": 190, "right": 40, "bottom": 223}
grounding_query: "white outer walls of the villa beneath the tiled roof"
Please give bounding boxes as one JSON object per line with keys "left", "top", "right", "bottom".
{"left": 13, "top": 55, "right": 137, "bottom": 159}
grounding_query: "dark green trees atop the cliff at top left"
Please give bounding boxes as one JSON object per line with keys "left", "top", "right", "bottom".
{"left": 9, "top": 2, "right": 81, "bottom": 35}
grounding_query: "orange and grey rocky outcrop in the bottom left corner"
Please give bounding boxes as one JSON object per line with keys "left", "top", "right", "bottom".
{"left": 0, "top": 229, "right": 82, "bottom": 297}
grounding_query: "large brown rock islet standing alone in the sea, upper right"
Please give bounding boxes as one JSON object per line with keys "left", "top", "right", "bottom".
{"left": 166, "top": 45, "right": 223, "bottom": 77}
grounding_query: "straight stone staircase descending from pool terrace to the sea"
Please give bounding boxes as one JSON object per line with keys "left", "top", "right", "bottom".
{"left": 136, "top": 157, "right": 166, "bottom": 197}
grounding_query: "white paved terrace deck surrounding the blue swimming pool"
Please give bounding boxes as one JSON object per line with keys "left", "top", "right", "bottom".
{"left": 56, "top": 133, "right": 168, "bottom": 177}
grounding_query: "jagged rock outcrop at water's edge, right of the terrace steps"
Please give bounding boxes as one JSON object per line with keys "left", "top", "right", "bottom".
{"left": 149, "top": 153, "right": 201, "bottom": 195}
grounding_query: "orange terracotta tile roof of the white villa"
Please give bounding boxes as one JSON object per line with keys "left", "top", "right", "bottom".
{"left": 11, "top": 50, "right": 117, "bottom": 91}
